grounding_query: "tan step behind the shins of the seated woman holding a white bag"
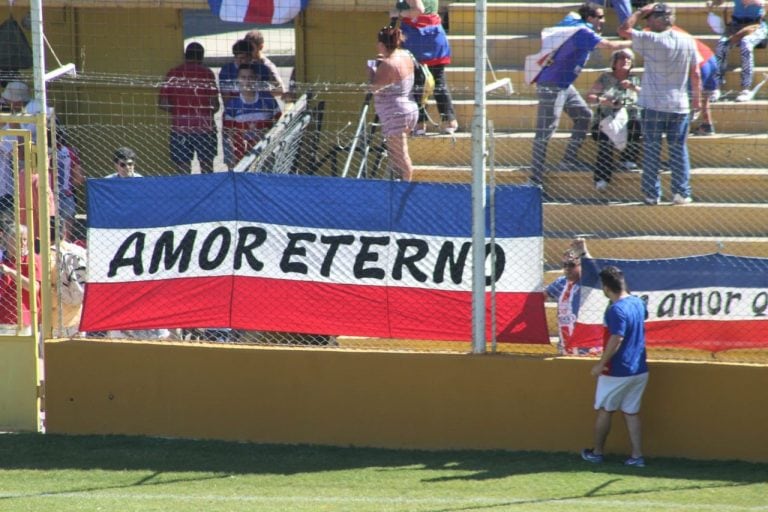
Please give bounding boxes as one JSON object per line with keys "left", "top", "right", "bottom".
{"left": 408, "top": 131, "right": 768, "bottom": 168}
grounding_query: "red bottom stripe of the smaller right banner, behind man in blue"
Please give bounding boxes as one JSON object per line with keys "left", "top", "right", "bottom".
{"left": 569, "top": 320, "right": 768, "bottom": 352}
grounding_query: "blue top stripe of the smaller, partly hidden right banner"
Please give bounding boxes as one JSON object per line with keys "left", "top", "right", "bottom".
{"left": 581, "top": 254, "right": 768, "bottom": 292}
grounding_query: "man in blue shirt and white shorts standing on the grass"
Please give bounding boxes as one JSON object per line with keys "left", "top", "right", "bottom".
{"left": 581, "top": 266, "right": 648, "bottom": 467}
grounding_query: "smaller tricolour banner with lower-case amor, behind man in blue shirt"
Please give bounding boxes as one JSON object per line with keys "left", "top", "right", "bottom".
{"left": 571, "top": 254, "right": 768, "bottom": 352}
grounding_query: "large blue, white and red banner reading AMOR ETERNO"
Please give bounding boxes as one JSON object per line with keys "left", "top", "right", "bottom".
{"left": 81, "top": 173, "right": 549, "bottom": 343}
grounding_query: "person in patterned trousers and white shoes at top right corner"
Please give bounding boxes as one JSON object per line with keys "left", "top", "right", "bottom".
{"left": 712, "top": 0, "right": 768, "bottom": 101}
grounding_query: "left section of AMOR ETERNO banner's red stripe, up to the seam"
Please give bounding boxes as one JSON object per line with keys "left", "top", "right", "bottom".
{"left": 80, "top": 277, "right": 232, "bottom": 331}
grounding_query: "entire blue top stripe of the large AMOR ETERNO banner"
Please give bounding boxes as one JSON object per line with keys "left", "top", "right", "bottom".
{"left": 88, "top": 173, "right": 542, "bottom": 238}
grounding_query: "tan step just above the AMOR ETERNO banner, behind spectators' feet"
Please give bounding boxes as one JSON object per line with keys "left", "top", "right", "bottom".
{"left": 414, "top": 165, "right": 768, "bottom": 202}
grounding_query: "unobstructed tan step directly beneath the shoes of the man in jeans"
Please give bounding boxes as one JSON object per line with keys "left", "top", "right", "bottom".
{"left": 544, "top": 202, "right": 768, "bottom": 237}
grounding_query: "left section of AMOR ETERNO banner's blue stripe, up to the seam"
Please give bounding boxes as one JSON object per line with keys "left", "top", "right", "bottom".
{"left": 86, "top": 173, "right": 237, "bottom": 229}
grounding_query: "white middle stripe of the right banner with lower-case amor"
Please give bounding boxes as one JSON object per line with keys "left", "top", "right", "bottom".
{"left": 579, "top": 286, "right": 768, "bottom": 324}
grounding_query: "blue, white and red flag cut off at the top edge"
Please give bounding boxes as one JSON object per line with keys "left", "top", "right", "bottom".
{"left": 208, "top": 0, "right": 309, "bottom": 25}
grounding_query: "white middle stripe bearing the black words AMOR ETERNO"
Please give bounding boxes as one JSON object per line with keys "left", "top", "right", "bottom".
{"left": 88, "top": 221, "right": 543, "bottom": 292}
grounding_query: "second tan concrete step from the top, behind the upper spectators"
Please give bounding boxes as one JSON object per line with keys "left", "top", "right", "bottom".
{"left": 448, "top": 35, "right": 768, "bottom": 69}
